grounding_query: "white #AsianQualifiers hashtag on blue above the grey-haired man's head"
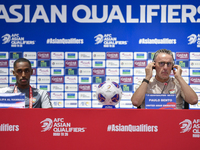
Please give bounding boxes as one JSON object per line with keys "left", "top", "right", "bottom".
{"left": 139, "top": 38, "right": 176, "bottom": 45}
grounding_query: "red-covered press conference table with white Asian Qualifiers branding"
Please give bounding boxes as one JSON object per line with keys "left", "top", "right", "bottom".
{"left": 0, "top": 109, "right": 200, "bottom": 150}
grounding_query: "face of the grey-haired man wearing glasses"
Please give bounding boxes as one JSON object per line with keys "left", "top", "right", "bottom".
{"left": 155, "top": 53, "right": 173, "bottom": 82}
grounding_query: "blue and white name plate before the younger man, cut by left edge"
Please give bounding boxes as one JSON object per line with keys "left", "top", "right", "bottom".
{"left": 0, "top": 93, "right": 25, "bottom": 108}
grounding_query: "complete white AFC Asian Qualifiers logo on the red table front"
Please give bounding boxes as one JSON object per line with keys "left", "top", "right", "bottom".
{"left": 40, "top": 118, "right": 86, "bottom": 136}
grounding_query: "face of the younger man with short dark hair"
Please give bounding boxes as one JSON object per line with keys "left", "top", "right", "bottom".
{"left": 13, "top": 62, "right": 33, "bottom": 88}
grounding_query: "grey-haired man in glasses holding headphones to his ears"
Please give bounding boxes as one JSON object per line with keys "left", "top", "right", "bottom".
{"left": 131, "top": 49, "right": 198, "bottom": 109}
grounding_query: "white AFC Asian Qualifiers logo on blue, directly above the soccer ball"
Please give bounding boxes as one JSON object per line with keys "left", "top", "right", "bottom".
{"left": 94, "top": 34, "right": 128, "bottom": 48}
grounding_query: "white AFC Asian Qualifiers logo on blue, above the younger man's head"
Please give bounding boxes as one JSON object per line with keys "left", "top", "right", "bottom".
{"left": 1, "top": 33, "right": 35, "bottom": 47}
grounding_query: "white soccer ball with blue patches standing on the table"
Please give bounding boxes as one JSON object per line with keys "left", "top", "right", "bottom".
{"left": 96, "top": 81, "right": 122, "bottom": 105}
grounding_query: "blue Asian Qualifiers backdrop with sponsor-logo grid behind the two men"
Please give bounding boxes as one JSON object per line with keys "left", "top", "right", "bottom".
{"left": 0, "top": 0, "right": 200, "bottom": 109}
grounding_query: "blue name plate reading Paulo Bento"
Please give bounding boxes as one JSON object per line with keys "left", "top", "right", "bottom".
{"left": 145, "top": 94, "right": 176, "bottom": 109}
